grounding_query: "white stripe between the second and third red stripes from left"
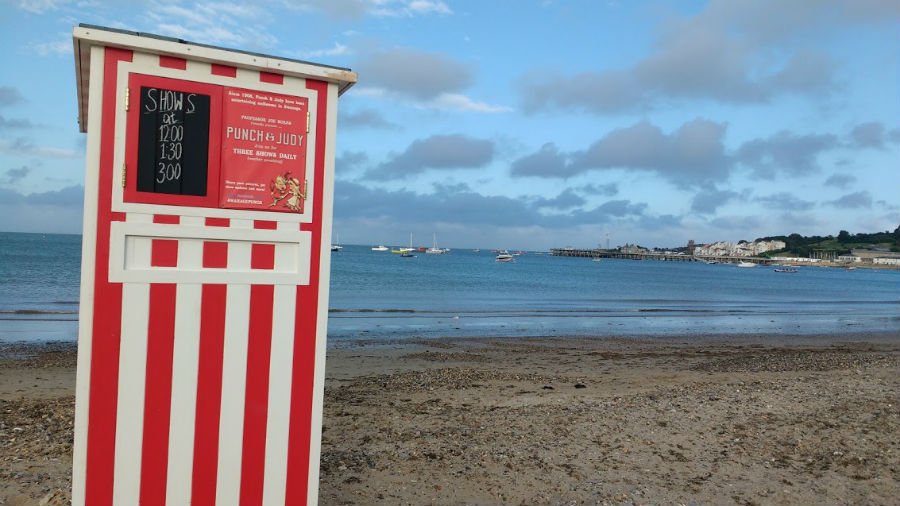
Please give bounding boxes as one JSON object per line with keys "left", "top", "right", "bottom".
{"left": 166, "top": 224, "right": 203, "bottom": 506}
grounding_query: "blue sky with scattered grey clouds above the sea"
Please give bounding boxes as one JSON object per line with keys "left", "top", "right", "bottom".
{"left": 0, "top": 0, "right": 900, "bottom": 250}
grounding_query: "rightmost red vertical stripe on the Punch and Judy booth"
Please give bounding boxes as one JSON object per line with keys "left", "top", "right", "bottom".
{"left": 285, "top": 80, "right": 328, "bottom": 504}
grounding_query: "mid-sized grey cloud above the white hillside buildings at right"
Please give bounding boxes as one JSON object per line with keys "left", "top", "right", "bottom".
{"left": 735, "top": 130, "right": 839, "bottom": 179}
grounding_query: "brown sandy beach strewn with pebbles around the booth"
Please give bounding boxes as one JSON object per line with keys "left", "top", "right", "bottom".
{"left": 0, "top": 334, "right": 900, "bottom": 505}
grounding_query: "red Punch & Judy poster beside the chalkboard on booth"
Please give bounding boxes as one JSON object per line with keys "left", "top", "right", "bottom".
{"left": 219, "top": 87, "right": 309, "bottom": 213}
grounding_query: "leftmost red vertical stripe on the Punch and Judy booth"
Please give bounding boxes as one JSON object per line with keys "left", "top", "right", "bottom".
{"left": 85, "top": 44, "right": 132, "bottom": 506}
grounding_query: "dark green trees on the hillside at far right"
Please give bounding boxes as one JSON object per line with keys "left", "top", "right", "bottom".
{"left": 757, "top": 226, "right": 900, "bottom": 257}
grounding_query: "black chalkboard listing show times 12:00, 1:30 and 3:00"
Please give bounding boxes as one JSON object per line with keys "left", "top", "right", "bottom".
{"left": 137, "top": 86, "right": 210, "bottom": 196}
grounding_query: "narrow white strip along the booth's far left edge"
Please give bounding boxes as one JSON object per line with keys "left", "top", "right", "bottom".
{"left": 72, "top": 42, "right": 104, "bottom": 506}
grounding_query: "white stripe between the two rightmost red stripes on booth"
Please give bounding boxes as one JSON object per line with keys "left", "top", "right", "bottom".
{"left": 263, "top": 231, "right": 297, "bottom": 506}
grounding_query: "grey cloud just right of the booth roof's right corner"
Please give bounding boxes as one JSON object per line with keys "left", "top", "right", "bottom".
{"left": 357, "top": 48, "right": 474, "bottom": 102}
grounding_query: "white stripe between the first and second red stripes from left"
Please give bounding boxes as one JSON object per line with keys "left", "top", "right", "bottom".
{"left": 110, "top": 214, "right": 153, "bottom": 506}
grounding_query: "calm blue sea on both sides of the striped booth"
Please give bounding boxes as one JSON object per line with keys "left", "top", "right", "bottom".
{"left": 0, "top": 233, "right": 900, "bottom": 343}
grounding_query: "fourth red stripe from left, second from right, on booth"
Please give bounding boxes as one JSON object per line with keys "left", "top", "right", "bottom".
{"left": 240, "top": 231, "right": 275, "bottom": 506}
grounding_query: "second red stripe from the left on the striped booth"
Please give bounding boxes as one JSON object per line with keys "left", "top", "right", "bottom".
{"left": 140, "top": 234, "right": 178, "bottom": 504}
